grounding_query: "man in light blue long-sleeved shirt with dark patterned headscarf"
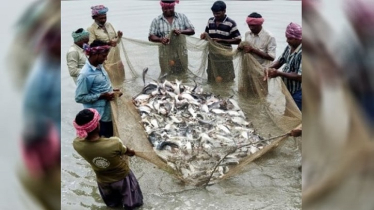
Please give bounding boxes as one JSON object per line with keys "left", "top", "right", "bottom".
{"left": 75, "top": 40, "right": 122, "bottom": 138}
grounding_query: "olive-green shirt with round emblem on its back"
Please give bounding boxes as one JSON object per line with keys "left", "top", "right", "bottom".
{"left": 73, "top": 137, "right": 130, "bottom": 183}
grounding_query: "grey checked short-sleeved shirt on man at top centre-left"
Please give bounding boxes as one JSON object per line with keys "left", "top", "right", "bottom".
{"left": 149, "top": 12, "right": 195, "bottom": 37}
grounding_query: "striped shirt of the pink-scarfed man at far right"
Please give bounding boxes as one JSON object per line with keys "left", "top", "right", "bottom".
{"left": 278, "top": 44, "right": 302, "bottom": 95}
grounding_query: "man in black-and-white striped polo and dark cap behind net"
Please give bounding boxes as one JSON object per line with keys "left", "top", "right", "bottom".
{"left": 200, "top": 1, "right": 241, "bottom": 82}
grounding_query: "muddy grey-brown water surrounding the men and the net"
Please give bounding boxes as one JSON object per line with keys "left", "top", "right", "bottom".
{"left": 61, "top": 1, "right": 301, "bottom": 209}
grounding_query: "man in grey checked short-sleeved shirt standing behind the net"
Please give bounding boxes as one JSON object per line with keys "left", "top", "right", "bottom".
{"left": 148, "top": 0, "right": 195, "bottom": 74}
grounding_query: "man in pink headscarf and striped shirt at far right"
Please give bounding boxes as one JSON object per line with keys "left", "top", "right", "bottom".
{"left": 264, "top": 23, "right": 302, "bottom": 111}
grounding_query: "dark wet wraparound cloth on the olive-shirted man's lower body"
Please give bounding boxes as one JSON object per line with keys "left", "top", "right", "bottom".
{"left": 98, "top": 170, "right": 143, "bottom": 209}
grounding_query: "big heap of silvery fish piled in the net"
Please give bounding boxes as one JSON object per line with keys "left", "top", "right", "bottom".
{"left": 133, "top": 80, "right": 265, "bottom": 183}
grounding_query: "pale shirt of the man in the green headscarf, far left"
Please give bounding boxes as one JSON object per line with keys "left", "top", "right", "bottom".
{"left": 66, "top": 44, "right": 87, "bottom": 84}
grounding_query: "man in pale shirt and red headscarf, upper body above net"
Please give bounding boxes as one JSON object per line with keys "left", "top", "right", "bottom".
{"left": 238, "top": 12, "right": 277, "bottom": 67}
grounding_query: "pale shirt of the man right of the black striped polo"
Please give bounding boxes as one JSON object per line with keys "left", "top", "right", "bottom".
{"left": 245, "top": 29, "right": 277, "bottom": 67}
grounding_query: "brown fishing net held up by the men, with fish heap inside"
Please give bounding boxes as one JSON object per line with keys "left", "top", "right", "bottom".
{"left": 111, "top": 31, "right": 301, "bottom": 185}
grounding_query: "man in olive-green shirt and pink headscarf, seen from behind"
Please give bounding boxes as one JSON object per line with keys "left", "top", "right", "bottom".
{"left": 73, "top": 108, "right": 143, "bottom": 209}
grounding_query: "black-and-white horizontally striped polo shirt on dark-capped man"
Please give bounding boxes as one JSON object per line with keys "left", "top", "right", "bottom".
{"left": 205, "top": 15, "right": 242, "bottom": 45}
